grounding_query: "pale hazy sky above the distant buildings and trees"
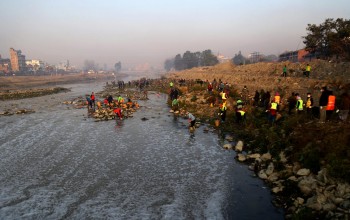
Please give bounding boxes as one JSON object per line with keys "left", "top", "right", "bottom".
{"left": 0, "top": 0, "right": 350, "bottom": 68}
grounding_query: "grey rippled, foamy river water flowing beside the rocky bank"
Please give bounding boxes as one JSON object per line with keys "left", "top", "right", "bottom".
{"left": 0, "top": 84, "right": 283, "bottom": 220}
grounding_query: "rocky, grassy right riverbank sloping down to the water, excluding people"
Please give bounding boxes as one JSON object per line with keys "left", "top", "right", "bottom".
{"left": 163, "top": 61, "right": 350, "bottom": 219}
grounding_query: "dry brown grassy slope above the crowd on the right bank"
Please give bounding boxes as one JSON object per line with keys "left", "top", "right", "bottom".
{"left": 167, "top": 60, "right": 350, "bottom": 99}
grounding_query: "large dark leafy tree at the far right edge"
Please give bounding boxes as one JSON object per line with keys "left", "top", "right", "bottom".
{"left": 303, "top": 18, "right": 350, "bottom": 60}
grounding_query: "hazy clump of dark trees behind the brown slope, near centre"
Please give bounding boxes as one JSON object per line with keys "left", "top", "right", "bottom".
{"left": 164, "top": 50, "right": 219, "bottom": 71}
